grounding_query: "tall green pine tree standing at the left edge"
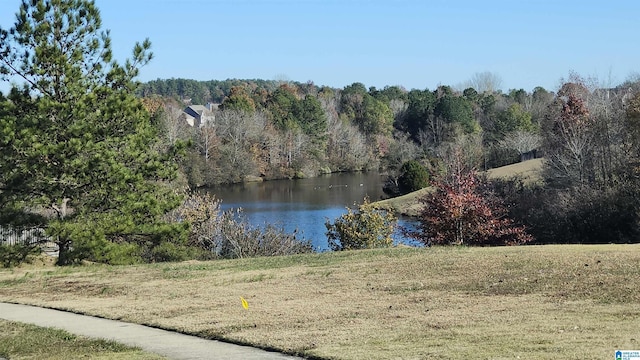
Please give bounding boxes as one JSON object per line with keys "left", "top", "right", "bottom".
{"left": 0, "top": 0, "right": 186, "bottom": 265}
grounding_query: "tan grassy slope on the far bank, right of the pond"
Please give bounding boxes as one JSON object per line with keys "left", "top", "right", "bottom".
{"left": 376, "top": 159, "right": 543, "bottom": 216}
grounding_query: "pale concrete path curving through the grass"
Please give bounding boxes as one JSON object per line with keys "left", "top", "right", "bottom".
{"left": 0, "top": 303, "right": 297, "bottom": 360}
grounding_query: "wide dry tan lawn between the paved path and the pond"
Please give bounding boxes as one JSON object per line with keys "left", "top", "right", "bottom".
{"left": 0, "top": 245, "right": 640, "bottom": 359}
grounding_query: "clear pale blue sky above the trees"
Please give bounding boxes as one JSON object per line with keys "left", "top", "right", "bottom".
{"left": 0, "top": 0, "right": 640, "bottom": 91}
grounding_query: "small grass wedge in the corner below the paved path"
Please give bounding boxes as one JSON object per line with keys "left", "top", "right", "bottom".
{"left": 0, "top": 320, "right": 165, "bottom": 360}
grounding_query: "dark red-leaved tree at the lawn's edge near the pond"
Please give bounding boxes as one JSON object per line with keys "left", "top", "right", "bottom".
{"left": 409, "top": 156, "right": 533, "bottom": 246}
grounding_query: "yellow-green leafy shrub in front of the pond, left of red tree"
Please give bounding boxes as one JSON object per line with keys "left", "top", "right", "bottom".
{"left": 325, "top": 198, "right": 397, "bottom": 251}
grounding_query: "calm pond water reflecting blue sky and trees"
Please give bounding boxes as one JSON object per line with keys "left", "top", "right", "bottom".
{"left": 209, "top": 172, "right": 422, "bottom": 251}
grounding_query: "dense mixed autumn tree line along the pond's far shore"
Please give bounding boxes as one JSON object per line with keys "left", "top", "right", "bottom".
{"left": 138, "top": 79, "right": 555, "bottom": 187}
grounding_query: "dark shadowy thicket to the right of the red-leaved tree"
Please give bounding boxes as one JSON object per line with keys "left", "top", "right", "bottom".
{"left": 492, "top": 174, "right": 640, "bottom": 244}
